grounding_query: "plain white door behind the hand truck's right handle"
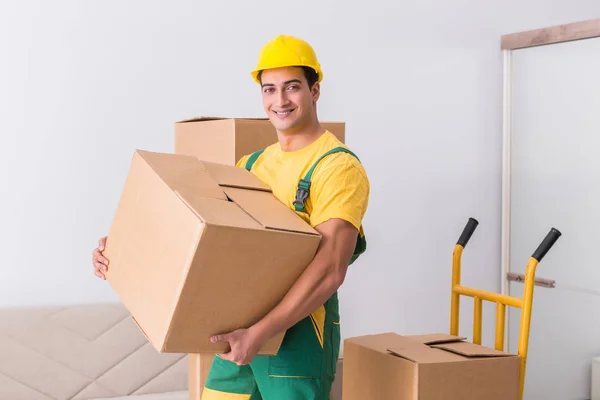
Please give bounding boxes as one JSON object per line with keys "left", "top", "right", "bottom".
{"left": 508, "top": 38, "right": 600, "bottom": 400}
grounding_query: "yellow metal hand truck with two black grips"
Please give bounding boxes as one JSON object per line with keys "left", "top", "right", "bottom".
{"left": 450, "top": 218, "right": 562, "bottom": 400}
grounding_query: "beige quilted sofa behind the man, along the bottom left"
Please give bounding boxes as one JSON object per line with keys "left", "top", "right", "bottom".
{"left": 0, "top": 303, "right": 341, "bottom": 400}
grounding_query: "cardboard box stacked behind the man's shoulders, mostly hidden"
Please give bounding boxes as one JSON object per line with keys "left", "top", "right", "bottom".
{"left": 175, "top": 117, "right": 345, "bottom": 165}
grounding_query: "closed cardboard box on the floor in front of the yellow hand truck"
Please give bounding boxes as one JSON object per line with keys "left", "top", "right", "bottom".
{"left": 342, "top": 333, "right": 519, "bottom": 400}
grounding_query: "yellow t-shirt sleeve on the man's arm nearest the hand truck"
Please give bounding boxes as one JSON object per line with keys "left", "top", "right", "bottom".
{"left": 310, "top": 156, "right": 370, "bottom": 229}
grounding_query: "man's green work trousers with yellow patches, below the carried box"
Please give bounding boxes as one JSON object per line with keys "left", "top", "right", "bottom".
{"left": 202, "top": 293, "right": 340, "bottom": 400}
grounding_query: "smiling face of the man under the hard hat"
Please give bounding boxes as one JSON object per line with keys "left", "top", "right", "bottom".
{"left": 261, "top": 67, "right": 319, "bottom": 133}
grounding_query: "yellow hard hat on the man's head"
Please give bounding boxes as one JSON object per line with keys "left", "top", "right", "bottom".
{"left": 251, "top": 35, "right": 323, "bottom": 83}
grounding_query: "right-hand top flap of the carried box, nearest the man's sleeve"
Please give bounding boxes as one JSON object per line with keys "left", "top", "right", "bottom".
{"left": 223, "top": 187, "right": 319, "bottom": 235}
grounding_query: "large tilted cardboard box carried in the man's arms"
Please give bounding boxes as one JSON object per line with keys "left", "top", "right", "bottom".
{"left": 105, "top": 151, "right": 321, "bottom": 354}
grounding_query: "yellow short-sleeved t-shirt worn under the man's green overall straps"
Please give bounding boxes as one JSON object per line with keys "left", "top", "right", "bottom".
{"left": 237, "top": 131, "right": 370, "bottom": 236}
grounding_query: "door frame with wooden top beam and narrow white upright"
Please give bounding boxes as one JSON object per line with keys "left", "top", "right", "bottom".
{"left": 500, "top": 18, "right": 600, "bottom": 350}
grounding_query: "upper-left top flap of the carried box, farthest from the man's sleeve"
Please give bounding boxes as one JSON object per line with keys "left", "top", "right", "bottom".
{"left": 134, "top": 150, "right": 227, "bottom": 201}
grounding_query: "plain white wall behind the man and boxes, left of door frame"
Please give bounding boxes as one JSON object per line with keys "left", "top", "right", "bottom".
{"left": 0, "top": 0, "right": 600, "bottom": 354}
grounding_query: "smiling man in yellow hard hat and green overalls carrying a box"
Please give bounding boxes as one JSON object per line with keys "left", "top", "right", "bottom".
{"left": 93, "top": 35, "right": 370, "bottom": 400}
